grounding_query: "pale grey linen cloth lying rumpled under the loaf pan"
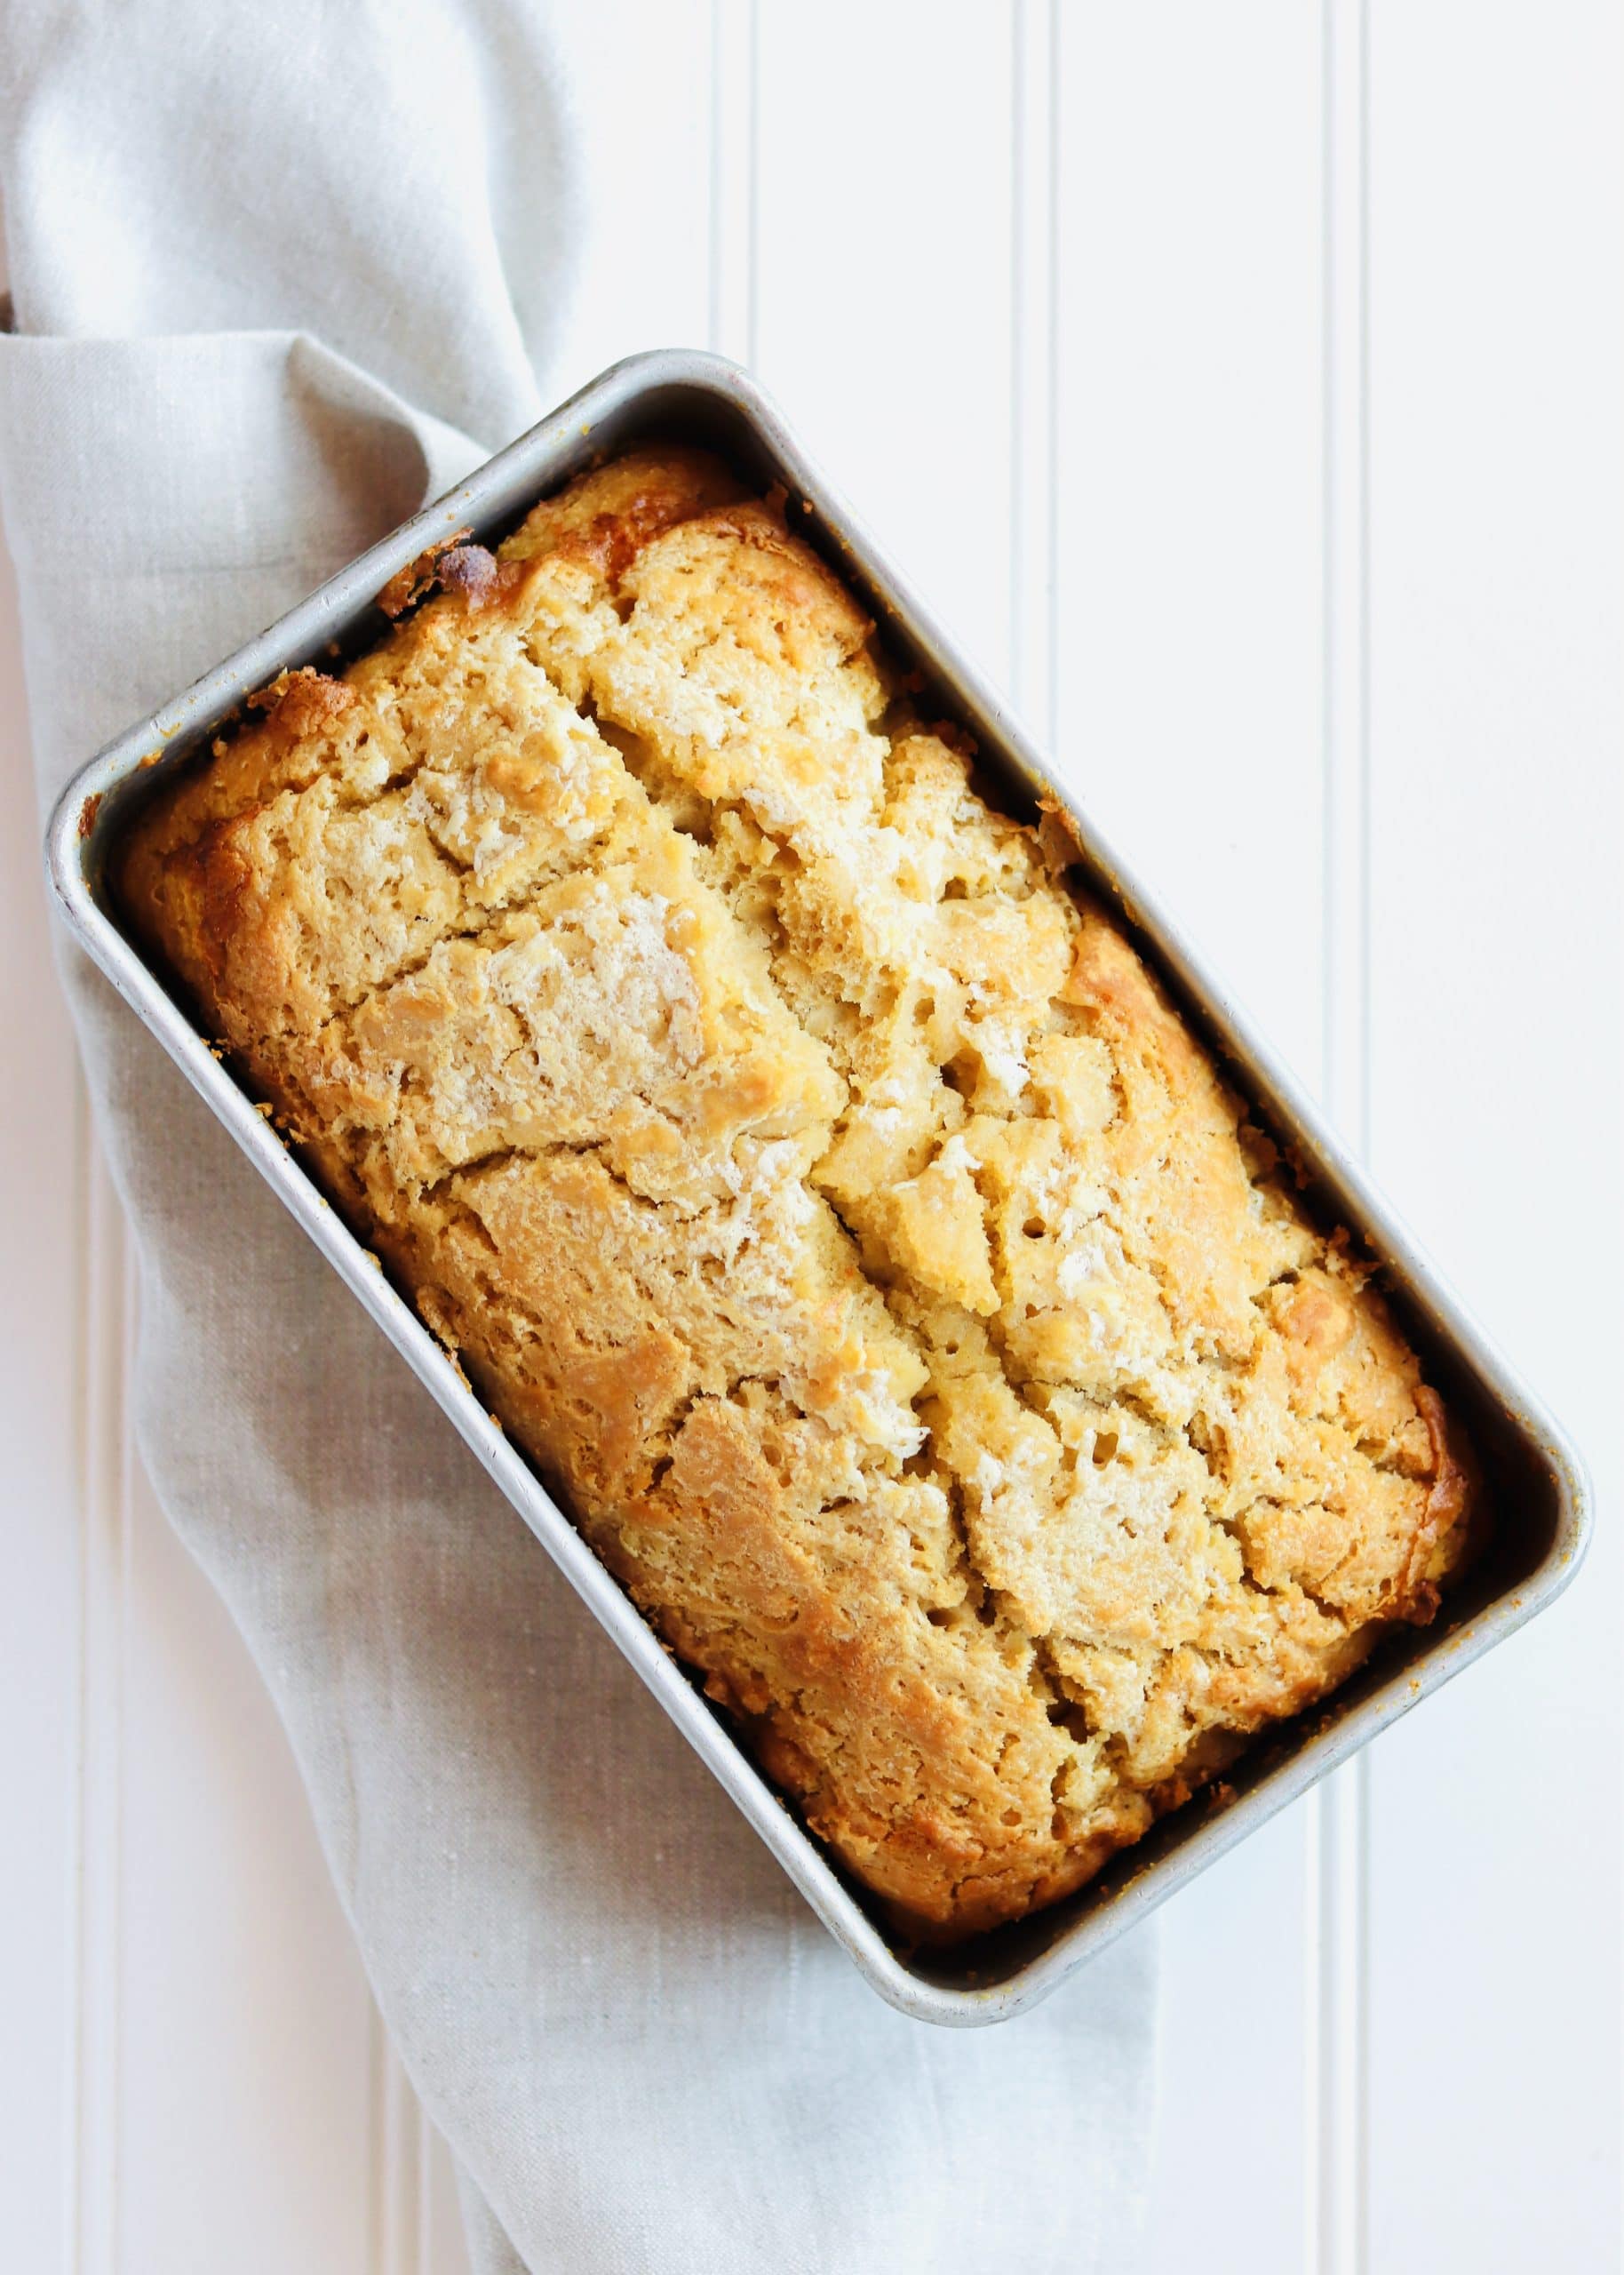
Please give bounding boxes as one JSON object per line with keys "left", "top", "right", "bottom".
{"left": 0, "top": 0, "right": 1153, "bottom": 2275}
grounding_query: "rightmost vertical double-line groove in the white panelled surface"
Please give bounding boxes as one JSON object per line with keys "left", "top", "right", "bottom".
{"left": 1306, "top": 0, "right": 1372, "bottom": 2275}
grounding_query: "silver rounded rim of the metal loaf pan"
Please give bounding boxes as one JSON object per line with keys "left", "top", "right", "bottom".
{"left": 45, "top": 348, "right": 1592, "bottom": 2027}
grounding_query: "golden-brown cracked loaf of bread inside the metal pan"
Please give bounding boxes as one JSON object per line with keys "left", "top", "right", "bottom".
{"left": 116, "top": 451, "right": 1474, "bottom": 1936}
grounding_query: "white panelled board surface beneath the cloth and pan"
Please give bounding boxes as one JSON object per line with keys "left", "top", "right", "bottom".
{"left": 0, "top": 0, "right": 1624, "bottom": 2275}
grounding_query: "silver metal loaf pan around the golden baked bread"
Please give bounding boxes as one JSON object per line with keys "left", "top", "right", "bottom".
{"left": 48, "top": 350, "right": 1590, "bottom": 2024}
